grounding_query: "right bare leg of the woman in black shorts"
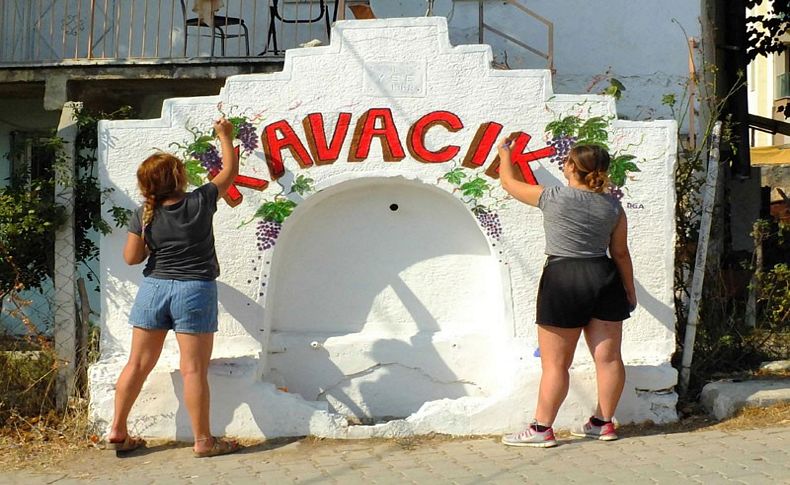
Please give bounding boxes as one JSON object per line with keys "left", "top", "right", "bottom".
{"left": 584, "top": 318, "right": 625, "bottom": 421}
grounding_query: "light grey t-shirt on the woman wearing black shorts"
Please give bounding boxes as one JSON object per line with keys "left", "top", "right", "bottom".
{"left": 538, "top": 185, "right": 623, "bottom": 258}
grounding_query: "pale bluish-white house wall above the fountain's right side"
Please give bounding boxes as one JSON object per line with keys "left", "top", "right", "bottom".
{"left": 378, "top": 0, "right": 702, "bottom": 120}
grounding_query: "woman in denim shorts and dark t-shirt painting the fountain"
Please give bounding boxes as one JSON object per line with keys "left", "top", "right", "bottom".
{"left": 106, "top": 118, "right": 239, "bottom": 457}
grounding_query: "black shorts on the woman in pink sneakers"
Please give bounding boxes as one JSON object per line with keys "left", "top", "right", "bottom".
{"left": 536, "top": 256, "right": 631, "bottom": 328}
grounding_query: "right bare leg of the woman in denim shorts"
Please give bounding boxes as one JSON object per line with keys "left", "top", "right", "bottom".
{"left": 176, "top": 333, "right": 214, "bottom": 452}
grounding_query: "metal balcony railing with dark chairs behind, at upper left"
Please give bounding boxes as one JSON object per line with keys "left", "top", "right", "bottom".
{"left": 0, "top": 0, "right": 336, "bottom": 65}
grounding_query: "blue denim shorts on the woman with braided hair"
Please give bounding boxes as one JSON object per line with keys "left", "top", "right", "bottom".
{"left": 129, "top": 277, "right": 217, "bottom": 333}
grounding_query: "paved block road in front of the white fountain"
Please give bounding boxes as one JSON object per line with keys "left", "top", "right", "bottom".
{"left": 0, "top": 427, "right": 790, "bottom": 485}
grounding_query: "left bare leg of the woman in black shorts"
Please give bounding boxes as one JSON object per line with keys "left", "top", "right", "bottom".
{"left": 535, "top": 325, "right": 582, "bottom": 426}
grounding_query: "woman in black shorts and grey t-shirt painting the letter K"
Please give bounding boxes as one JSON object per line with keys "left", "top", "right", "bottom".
{"left": 498, "top": 140, "right": 636, "bottom": 448}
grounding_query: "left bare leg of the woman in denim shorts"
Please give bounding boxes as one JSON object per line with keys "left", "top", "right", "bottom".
{"left": 107, "top": 327, "right": 167, "bottom": 442}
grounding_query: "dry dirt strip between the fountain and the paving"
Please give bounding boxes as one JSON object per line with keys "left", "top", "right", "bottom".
{"left": 0, "top": 403, "right": 790, "bottom": 471}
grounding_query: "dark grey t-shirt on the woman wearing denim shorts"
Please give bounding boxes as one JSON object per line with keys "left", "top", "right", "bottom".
{"left": 129, "top": 182, "right": 219, "bottom": 281}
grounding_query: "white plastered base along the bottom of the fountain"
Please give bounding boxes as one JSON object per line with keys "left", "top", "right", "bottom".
{"left": 90, "top": 356, "right": 677, "bottom": 441}
